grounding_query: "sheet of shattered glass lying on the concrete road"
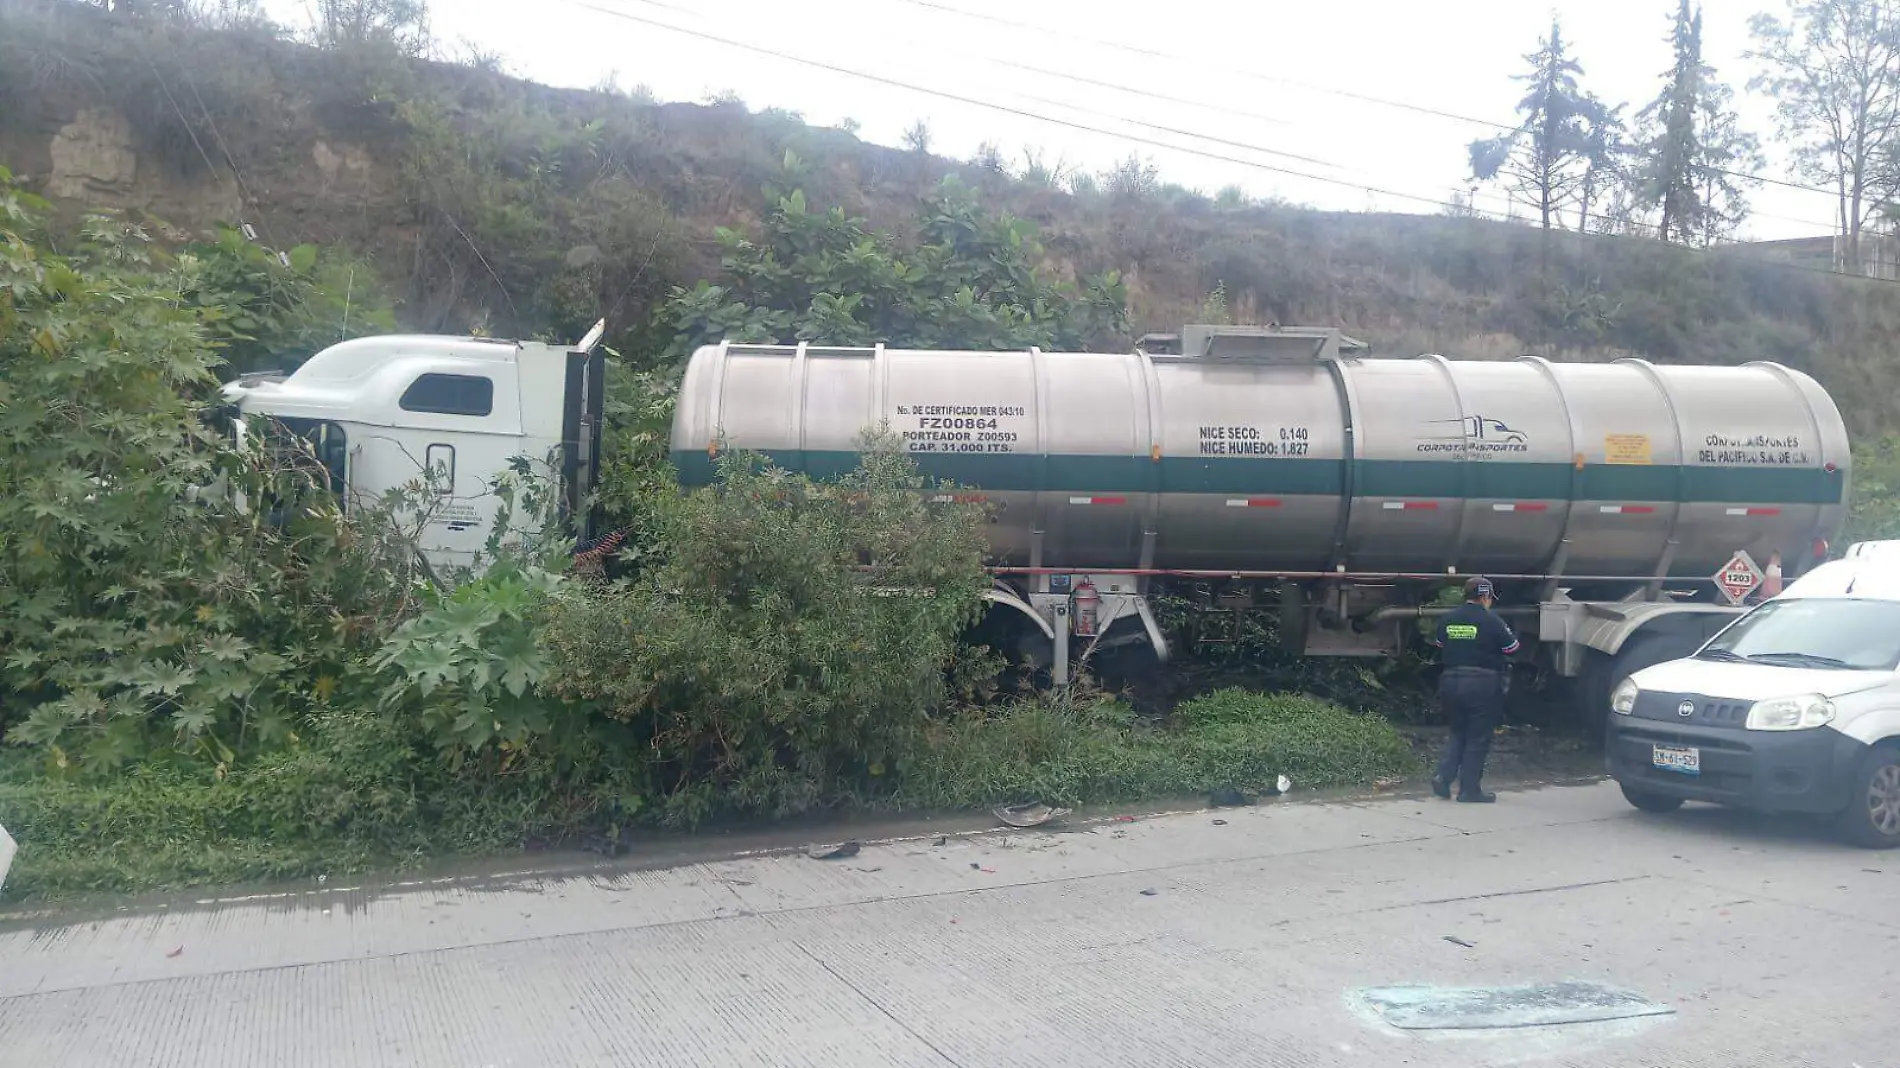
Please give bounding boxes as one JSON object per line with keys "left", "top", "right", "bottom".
{"left": 1359, "top": 982, "right": 1676, "bottom": 1030}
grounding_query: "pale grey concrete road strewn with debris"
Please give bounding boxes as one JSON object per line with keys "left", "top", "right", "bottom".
{"left": 0, "top": 785, "right": 1900, "bottom": 1068}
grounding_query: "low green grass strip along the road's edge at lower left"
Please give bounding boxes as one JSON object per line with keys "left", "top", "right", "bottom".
{"left": 0, "top": 713, "right": 615, "bottom": 903}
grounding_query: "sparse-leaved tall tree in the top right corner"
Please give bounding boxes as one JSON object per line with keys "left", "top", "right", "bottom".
{"left": 1750, "top": 0, "right": 1900, "bottom": 270}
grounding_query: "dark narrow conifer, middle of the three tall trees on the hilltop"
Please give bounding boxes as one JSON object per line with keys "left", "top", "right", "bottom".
{"left": 1632, "top": 0, "right": 1761, "bottom": 245}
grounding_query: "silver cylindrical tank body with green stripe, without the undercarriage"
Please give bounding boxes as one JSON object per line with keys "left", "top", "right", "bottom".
{"left": 671, "top": 327, "right": 1849, "bottom": 578}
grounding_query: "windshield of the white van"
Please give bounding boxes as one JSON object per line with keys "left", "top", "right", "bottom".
{"left": 1695, "top": 597, "right": 1900, "bottom": 671}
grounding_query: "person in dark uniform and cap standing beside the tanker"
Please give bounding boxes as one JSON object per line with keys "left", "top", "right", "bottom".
{"left": 1431, "top": 578, "right": 1518, "bottom": 804}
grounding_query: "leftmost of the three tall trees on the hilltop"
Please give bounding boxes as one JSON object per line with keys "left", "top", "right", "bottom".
{"left": 1471, "top": 19, "right": 1613, "bottom": 230}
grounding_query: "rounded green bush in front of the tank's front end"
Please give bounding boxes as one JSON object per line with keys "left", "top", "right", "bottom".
{"left": 543, "top": 433, "right": 988, "bottom": 823}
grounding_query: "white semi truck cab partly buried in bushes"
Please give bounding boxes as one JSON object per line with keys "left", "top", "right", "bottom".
{"left": 224, "top": 323, "right": 606, "bottom": 574}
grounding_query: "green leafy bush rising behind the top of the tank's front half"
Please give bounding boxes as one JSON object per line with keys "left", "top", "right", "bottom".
{"left": 661, "top": 179, "right": 1129, "bottom": 357}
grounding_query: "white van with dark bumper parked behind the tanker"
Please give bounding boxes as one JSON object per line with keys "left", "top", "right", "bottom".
{"left": 1607, "top": 542, "right": 1900, "bottom": 848}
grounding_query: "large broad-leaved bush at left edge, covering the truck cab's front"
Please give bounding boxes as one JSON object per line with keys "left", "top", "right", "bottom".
{"left": 0, "top": 171, "right": 403, "bottom": 768}
